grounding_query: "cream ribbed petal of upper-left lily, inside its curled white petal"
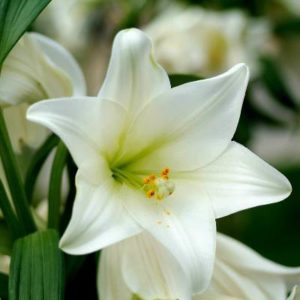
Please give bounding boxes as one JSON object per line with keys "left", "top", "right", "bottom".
{"left": 0, "top": 34, "right": 73, "bottom": 105}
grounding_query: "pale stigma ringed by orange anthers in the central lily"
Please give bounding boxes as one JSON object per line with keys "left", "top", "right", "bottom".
{"left": 143, "top": 168, "right": 175, "bottom": 201}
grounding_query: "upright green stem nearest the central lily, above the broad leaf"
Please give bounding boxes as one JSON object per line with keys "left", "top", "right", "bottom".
{"left": 48, "top": 142, "right": 68, "bottom": 230}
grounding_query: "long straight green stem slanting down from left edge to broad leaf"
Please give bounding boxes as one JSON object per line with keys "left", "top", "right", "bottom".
{"left": 0, "top": 108, "right": 36, "bottom": 233}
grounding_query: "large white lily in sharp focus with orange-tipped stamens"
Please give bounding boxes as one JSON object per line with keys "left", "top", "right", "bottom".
{"left": 27, "top": 29, "right": 291, "bottom": 292}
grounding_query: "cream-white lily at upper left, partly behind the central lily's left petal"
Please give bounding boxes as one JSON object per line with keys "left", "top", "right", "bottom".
{"left": 0, "top": 33, "right": 86, "bottom": 154}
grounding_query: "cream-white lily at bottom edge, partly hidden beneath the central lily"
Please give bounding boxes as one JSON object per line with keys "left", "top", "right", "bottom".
{"left": 98, "top": 233, "right": 300, "bottom": 300}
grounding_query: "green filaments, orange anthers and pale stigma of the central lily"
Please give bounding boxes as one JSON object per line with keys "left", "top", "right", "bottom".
{"left": 112, "top": 168, "right": 175, "bottom": 201}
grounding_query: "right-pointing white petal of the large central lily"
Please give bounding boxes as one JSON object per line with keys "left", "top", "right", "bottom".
{"left": 198, "top": 142, "right": 292, "bottom": 218}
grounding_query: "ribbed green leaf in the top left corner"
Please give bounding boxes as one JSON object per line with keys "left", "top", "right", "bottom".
{"left": 0, "top": 0, "right": 51, "bottom": 66}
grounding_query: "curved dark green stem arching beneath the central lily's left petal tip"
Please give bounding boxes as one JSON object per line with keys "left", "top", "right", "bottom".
{"left": 25, "top": 134, "right": 59, "bottom": 201}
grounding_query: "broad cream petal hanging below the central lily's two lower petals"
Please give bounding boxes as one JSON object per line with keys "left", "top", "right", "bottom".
{"left": 119, "top": 233, "right": 191, "bottom": 300}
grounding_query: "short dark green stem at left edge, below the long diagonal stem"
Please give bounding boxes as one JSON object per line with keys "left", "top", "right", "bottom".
{"left": 0, "top": 180, "right": 25, "bottom": 239}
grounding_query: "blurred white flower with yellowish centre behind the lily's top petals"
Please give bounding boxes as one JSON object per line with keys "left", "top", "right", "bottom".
{"left": 144, "top": 7, "right": 270, "bottom": 77}
